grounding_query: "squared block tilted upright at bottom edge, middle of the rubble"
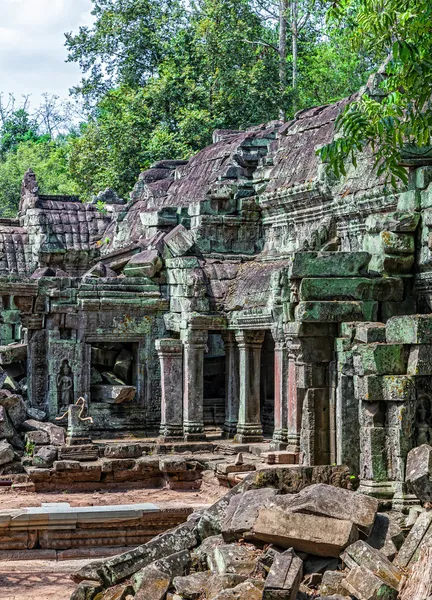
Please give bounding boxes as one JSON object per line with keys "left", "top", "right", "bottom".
{"left": 263, "top": 550, "right": 303, "bottom": 600}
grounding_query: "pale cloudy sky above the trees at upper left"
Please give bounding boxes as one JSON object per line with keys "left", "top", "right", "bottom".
{"left": 0, "top": 0, "right": 92, "bottom": 106}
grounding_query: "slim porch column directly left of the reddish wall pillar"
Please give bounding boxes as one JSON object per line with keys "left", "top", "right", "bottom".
{"left": 270, "top": 332, "right": 289, "bottom": 450}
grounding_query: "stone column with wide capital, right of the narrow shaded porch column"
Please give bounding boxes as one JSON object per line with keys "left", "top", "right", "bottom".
{"left": 235, "top": 331, "right": 265, "bottom": 443}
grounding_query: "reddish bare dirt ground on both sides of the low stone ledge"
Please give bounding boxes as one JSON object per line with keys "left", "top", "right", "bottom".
{"left": 0, "top": 476, "right": 227, "bottom": 600}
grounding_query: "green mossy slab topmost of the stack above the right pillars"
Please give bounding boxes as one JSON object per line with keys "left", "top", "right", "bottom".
{"left": 291, "top": 252, "right": 371, "bottom": 279}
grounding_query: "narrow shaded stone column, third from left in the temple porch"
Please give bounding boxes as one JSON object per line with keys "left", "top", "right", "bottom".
{"left": 223, "top": 331, "right": 240, "bottom": 438}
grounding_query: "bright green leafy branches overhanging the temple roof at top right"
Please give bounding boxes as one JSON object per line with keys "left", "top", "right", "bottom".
{"left": 319, "top": 0, "right": 432, "bottom": 187}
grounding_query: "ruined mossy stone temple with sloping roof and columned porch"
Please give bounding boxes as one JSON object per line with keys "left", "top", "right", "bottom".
{"left": 0, "top": 71, "right": 432, "bottom": 500}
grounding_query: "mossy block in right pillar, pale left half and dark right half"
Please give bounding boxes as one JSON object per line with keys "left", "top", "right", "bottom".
{"left": 353, "top": 344, "right": 408, "bottom": 377}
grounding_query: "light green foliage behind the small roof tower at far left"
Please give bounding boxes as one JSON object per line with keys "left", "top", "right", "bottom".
{"left": 0, "top": 140, "right": 75, "bottom": 217}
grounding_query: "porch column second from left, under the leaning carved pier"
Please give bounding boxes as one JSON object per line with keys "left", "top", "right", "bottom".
{"left": 181, "top": 329, "right": 208, "bottom": 441}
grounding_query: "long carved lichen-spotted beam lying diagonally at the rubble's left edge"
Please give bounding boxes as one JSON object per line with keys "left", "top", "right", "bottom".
{"left": 96, "top": 522, "right": 198, "bottom": 586}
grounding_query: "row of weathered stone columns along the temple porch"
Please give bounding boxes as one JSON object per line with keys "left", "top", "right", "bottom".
{"left": 156, "top": 329, "right": 308, "bottom": 451}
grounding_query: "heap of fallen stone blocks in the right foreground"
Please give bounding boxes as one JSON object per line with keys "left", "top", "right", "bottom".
{"left": 71, "top": 448, "right": 432, "bottom": 600}
